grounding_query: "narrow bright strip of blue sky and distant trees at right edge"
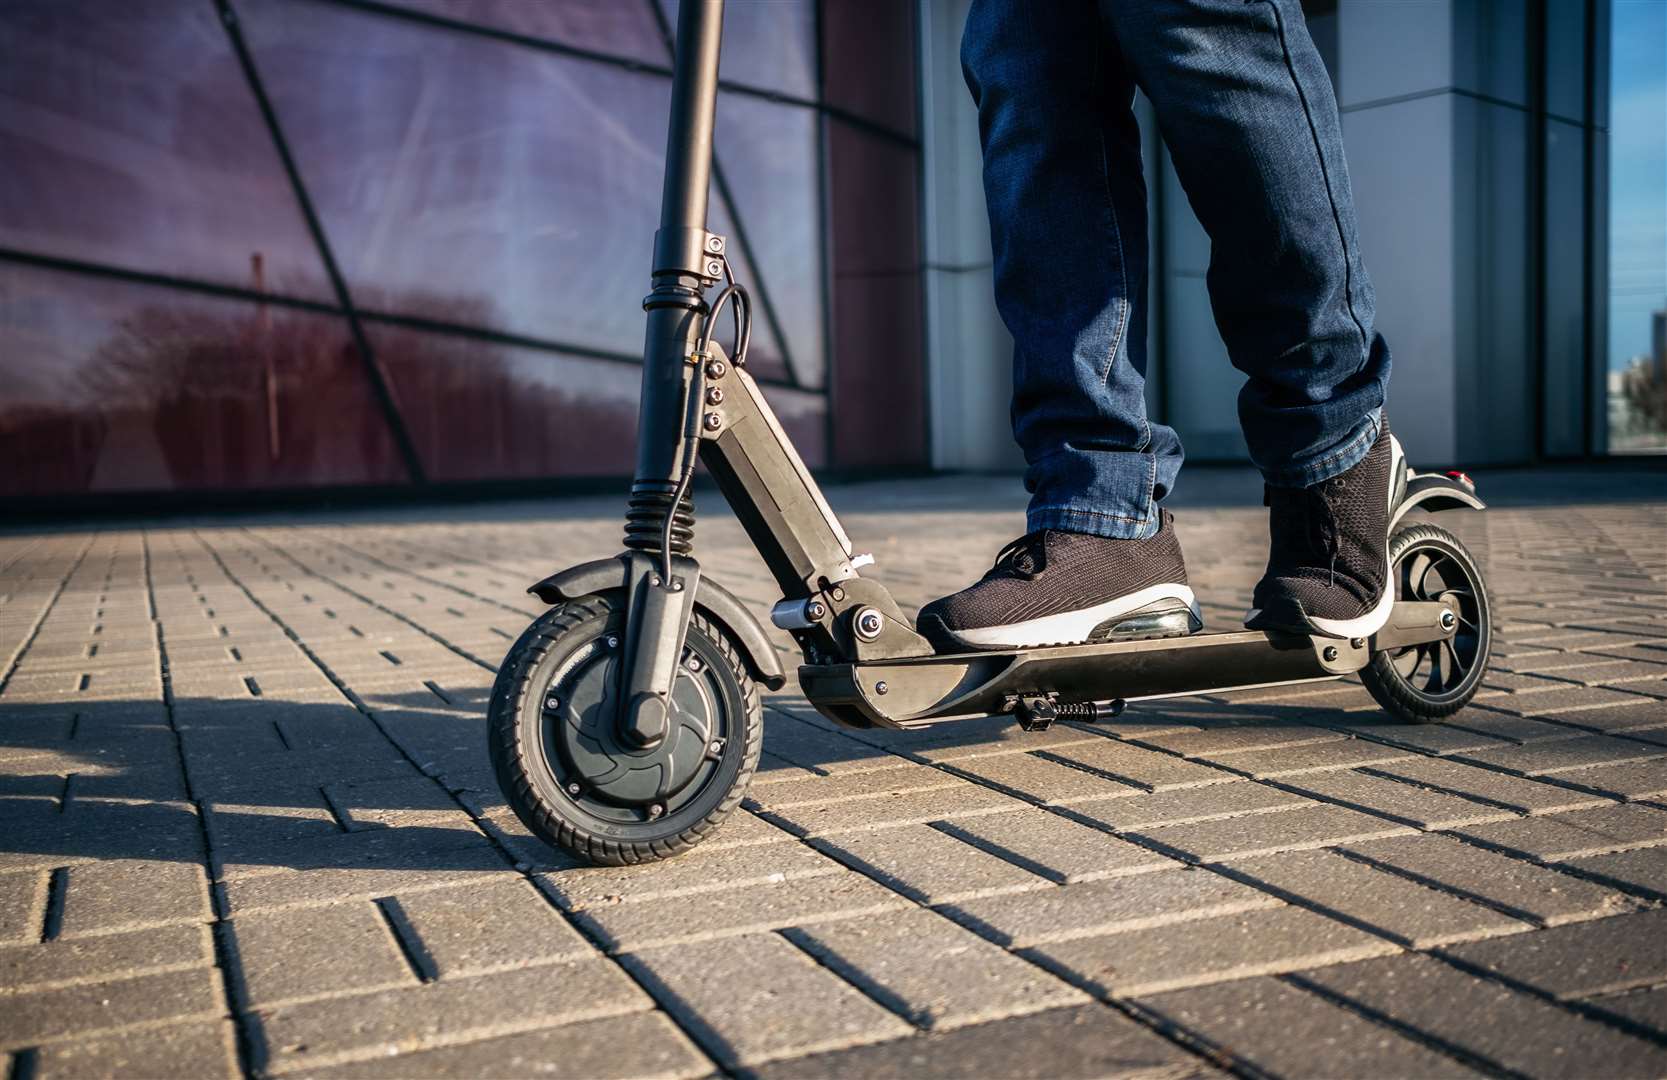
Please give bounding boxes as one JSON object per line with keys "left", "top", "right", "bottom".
{"left": 1607, "top": 0, "right": 1667, "bottom": 452}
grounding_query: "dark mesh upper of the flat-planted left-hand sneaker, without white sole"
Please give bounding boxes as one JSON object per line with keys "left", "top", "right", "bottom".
{"left": 917, "top": 510, "right": 1187, "bottom": 632}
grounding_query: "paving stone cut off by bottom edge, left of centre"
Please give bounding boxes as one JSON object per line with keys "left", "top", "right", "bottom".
{"left": 307, "top": 1012, "right": 712, "bottom": 1080}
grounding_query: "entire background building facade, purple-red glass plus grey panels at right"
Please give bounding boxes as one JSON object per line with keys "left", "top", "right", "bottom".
{"left": 0, "top": 0, "right": 1667, "bottom": 500}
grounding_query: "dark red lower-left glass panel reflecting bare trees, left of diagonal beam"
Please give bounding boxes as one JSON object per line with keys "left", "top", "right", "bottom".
{"left": 0, "top": 262, "right": 405, "bottom": 495}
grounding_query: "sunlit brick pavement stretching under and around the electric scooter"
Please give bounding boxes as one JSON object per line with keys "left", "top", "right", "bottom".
{"left": 0, "top": 468, "right": 1667, "bottom": 1077}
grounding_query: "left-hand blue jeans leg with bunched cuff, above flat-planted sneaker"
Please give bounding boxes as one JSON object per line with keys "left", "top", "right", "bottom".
{"left": 962, "top": 0, "right": 1182, "bottom": 538}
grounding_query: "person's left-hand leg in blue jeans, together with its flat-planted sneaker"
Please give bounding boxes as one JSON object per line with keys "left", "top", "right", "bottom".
{"left": 915, "top": 0, "right": 1200, "bottom": 652}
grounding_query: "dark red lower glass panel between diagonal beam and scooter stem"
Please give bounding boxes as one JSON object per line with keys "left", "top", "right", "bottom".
{"left": 365, "top": 323, "right": 642, "bottom": 482}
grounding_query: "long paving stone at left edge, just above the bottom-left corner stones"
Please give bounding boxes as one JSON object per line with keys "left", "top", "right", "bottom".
{"left": 0, "top": 967, "right": 225, "bottom": 1050}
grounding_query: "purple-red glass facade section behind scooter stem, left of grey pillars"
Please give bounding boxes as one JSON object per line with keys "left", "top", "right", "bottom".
{"left": 0, "top": 0, "right": 927, "bottom": 497}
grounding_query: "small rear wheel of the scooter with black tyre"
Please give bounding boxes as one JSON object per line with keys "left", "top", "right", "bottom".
{"left": 1360, "top": 522, "right": 1494, "bottom": 723}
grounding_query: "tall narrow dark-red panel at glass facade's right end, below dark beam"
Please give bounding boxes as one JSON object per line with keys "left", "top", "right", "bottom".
{"left": 828, "top": 120, "right": 927, "bottom": 467}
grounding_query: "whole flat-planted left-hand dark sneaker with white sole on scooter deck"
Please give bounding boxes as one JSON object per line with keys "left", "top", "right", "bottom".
{"left": 915, "top": 510, "right": 1204, "bottom": 652}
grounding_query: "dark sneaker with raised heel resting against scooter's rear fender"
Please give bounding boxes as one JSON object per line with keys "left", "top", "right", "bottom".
{"left": 1245, "top": 415, "right": 1407, "bottom": 638}
